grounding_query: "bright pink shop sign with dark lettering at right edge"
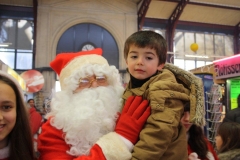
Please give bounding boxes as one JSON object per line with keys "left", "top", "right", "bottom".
{"left": 213, "top": 54, "right": 240, "bottom": 79}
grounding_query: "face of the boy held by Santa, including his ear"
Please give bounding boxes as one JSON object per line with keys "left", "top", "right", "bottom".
{"left": 126, "top": 45, "right": 164, "bottom": 79}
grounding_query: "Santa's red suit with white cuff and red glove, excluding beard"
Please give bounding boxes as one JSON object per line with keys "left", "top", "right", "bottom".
{"left": 38, "top": 96, "right": 150, "bottom": 160}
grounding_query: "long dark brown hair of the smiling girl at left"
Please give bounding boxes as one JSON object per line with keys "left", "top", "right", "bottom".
{"left": 0, "top": 74, "right": 35, "bottom": 160}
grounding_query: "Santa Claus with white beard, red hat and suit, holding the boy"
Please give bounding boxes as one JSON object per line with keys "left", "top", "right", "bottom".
{"left": 38, "top": 49, "right": 150, "bottom": 160}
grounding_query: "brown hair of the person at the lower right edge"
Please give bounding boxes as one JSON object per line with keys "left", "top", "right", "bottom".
{"left": 217, "top": 122, "right": 240, "bottom": 153}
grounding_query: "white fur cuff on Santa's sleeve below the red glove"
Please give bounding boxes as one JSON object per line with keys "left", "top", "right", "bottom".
{"left": 97, "top": 132, "right": 132, "bottom": 160}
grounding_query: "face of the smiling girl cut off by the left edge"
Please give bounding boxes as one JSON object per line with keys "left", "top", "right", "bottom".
{"left": 0, "top": 81, "right": 17, "bottom": 149}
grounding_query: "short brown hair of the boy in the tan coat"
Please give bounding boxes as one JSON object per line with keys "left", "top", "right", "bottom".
{"left": 124, "top": 31, "right": 167, "bottom": 65}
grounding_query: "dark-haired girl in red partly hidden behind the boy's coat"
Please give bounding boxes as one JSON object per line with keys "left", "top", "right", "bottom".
{"left": 181, "top": 103, "right": 218, "bottom": 160}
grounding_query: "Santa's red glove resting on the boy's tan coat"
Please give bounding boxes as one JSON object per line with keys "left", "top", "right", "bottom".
{"left": 115, "top": 96, "right": 151, "bottom": 144}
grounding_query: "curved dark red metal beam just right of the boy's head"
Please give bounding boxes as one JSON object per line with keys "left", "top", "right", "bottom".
{"left": 167, "top": 0, "right": 189, "bottom": 52}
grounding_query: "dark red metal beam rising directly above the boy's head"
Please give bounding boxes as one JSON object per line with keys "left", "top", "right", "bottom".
{"left": 138, "top": 0, "right": 151, "bottom": 30}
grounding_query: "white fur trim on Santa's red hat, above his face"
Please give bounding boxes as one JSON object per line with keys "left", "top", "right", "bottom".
{"left": 59, "top": 54, "right": 109, "bottom": 90}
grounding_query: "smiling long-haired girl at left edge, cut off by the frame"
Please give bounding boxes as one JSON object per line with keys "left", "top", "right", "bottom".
{"left": 0, "top": 71, "right": 35, "bottom": 160}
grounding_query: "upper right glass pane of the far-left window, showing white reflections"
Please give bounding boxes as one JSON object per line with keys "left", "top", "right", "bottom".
{"left": 17, "top": 20, "right": 33, "bottom": 49}
